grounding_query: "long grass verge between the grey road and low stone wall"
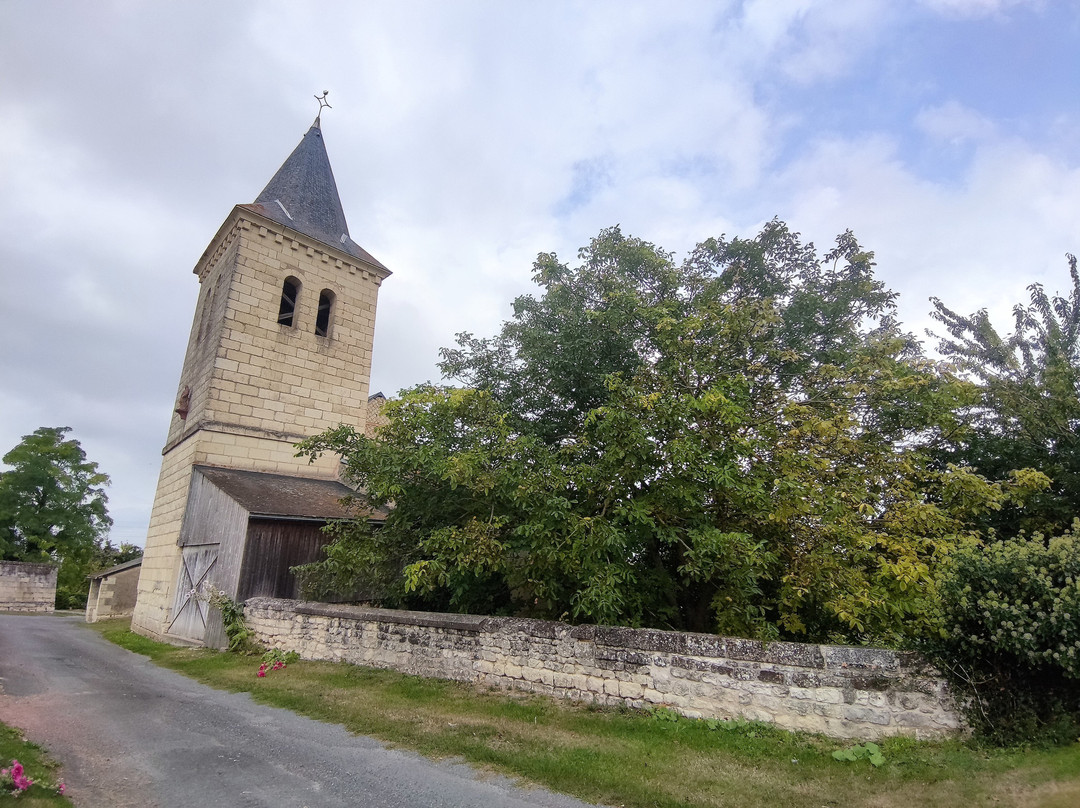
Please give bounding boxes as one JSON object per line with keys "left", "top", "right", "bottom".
{"left": 88, "top": 623, "right": 1080, "bottom": 808}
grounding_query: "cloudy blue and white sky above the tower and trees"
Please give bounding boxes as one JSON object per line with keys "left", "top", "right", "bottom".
{"left": 0, "top": 0, "right": 1080, "bottom": 543}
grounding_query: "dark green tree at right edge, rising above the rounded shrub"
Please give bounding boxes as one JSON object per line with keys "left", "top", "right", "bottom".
{"left": 932, "top": 255, "right": 1080, "bottom": 536}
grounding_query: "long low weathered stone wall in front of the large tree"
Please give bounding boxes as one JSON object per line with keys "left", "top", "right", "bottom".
{"left": 244, "top": 597, "right": 963, "bottom": 739}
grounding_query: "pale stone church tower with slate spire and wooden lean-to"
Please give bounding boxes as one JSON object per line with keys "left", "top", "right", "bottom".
{"left": 132, "top": 118, "right": 390, "bottom": 645}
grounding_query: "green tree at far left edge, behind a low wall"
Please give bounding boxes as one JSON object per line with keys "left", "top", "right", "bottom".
{"left": 0, "top": 427, "right": 112, "bottom": 607}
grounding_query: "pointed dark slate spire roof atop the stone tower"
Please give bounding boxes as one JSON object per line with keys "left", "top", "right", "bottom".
{"left": 252, "top": 118, "right": 384, "bottom": 268}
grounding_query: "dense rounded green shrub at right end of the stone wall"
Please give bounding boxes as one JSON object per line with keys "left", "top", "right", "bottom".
{"left": 928, "top": 520, "right": 1080, "bottom": 745}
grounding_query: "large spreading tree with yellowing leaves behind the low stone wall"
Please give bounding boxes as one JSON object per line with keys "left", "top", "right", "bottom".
{"left": 303, "top": 221, "right": 1043, "bottom": 639}
